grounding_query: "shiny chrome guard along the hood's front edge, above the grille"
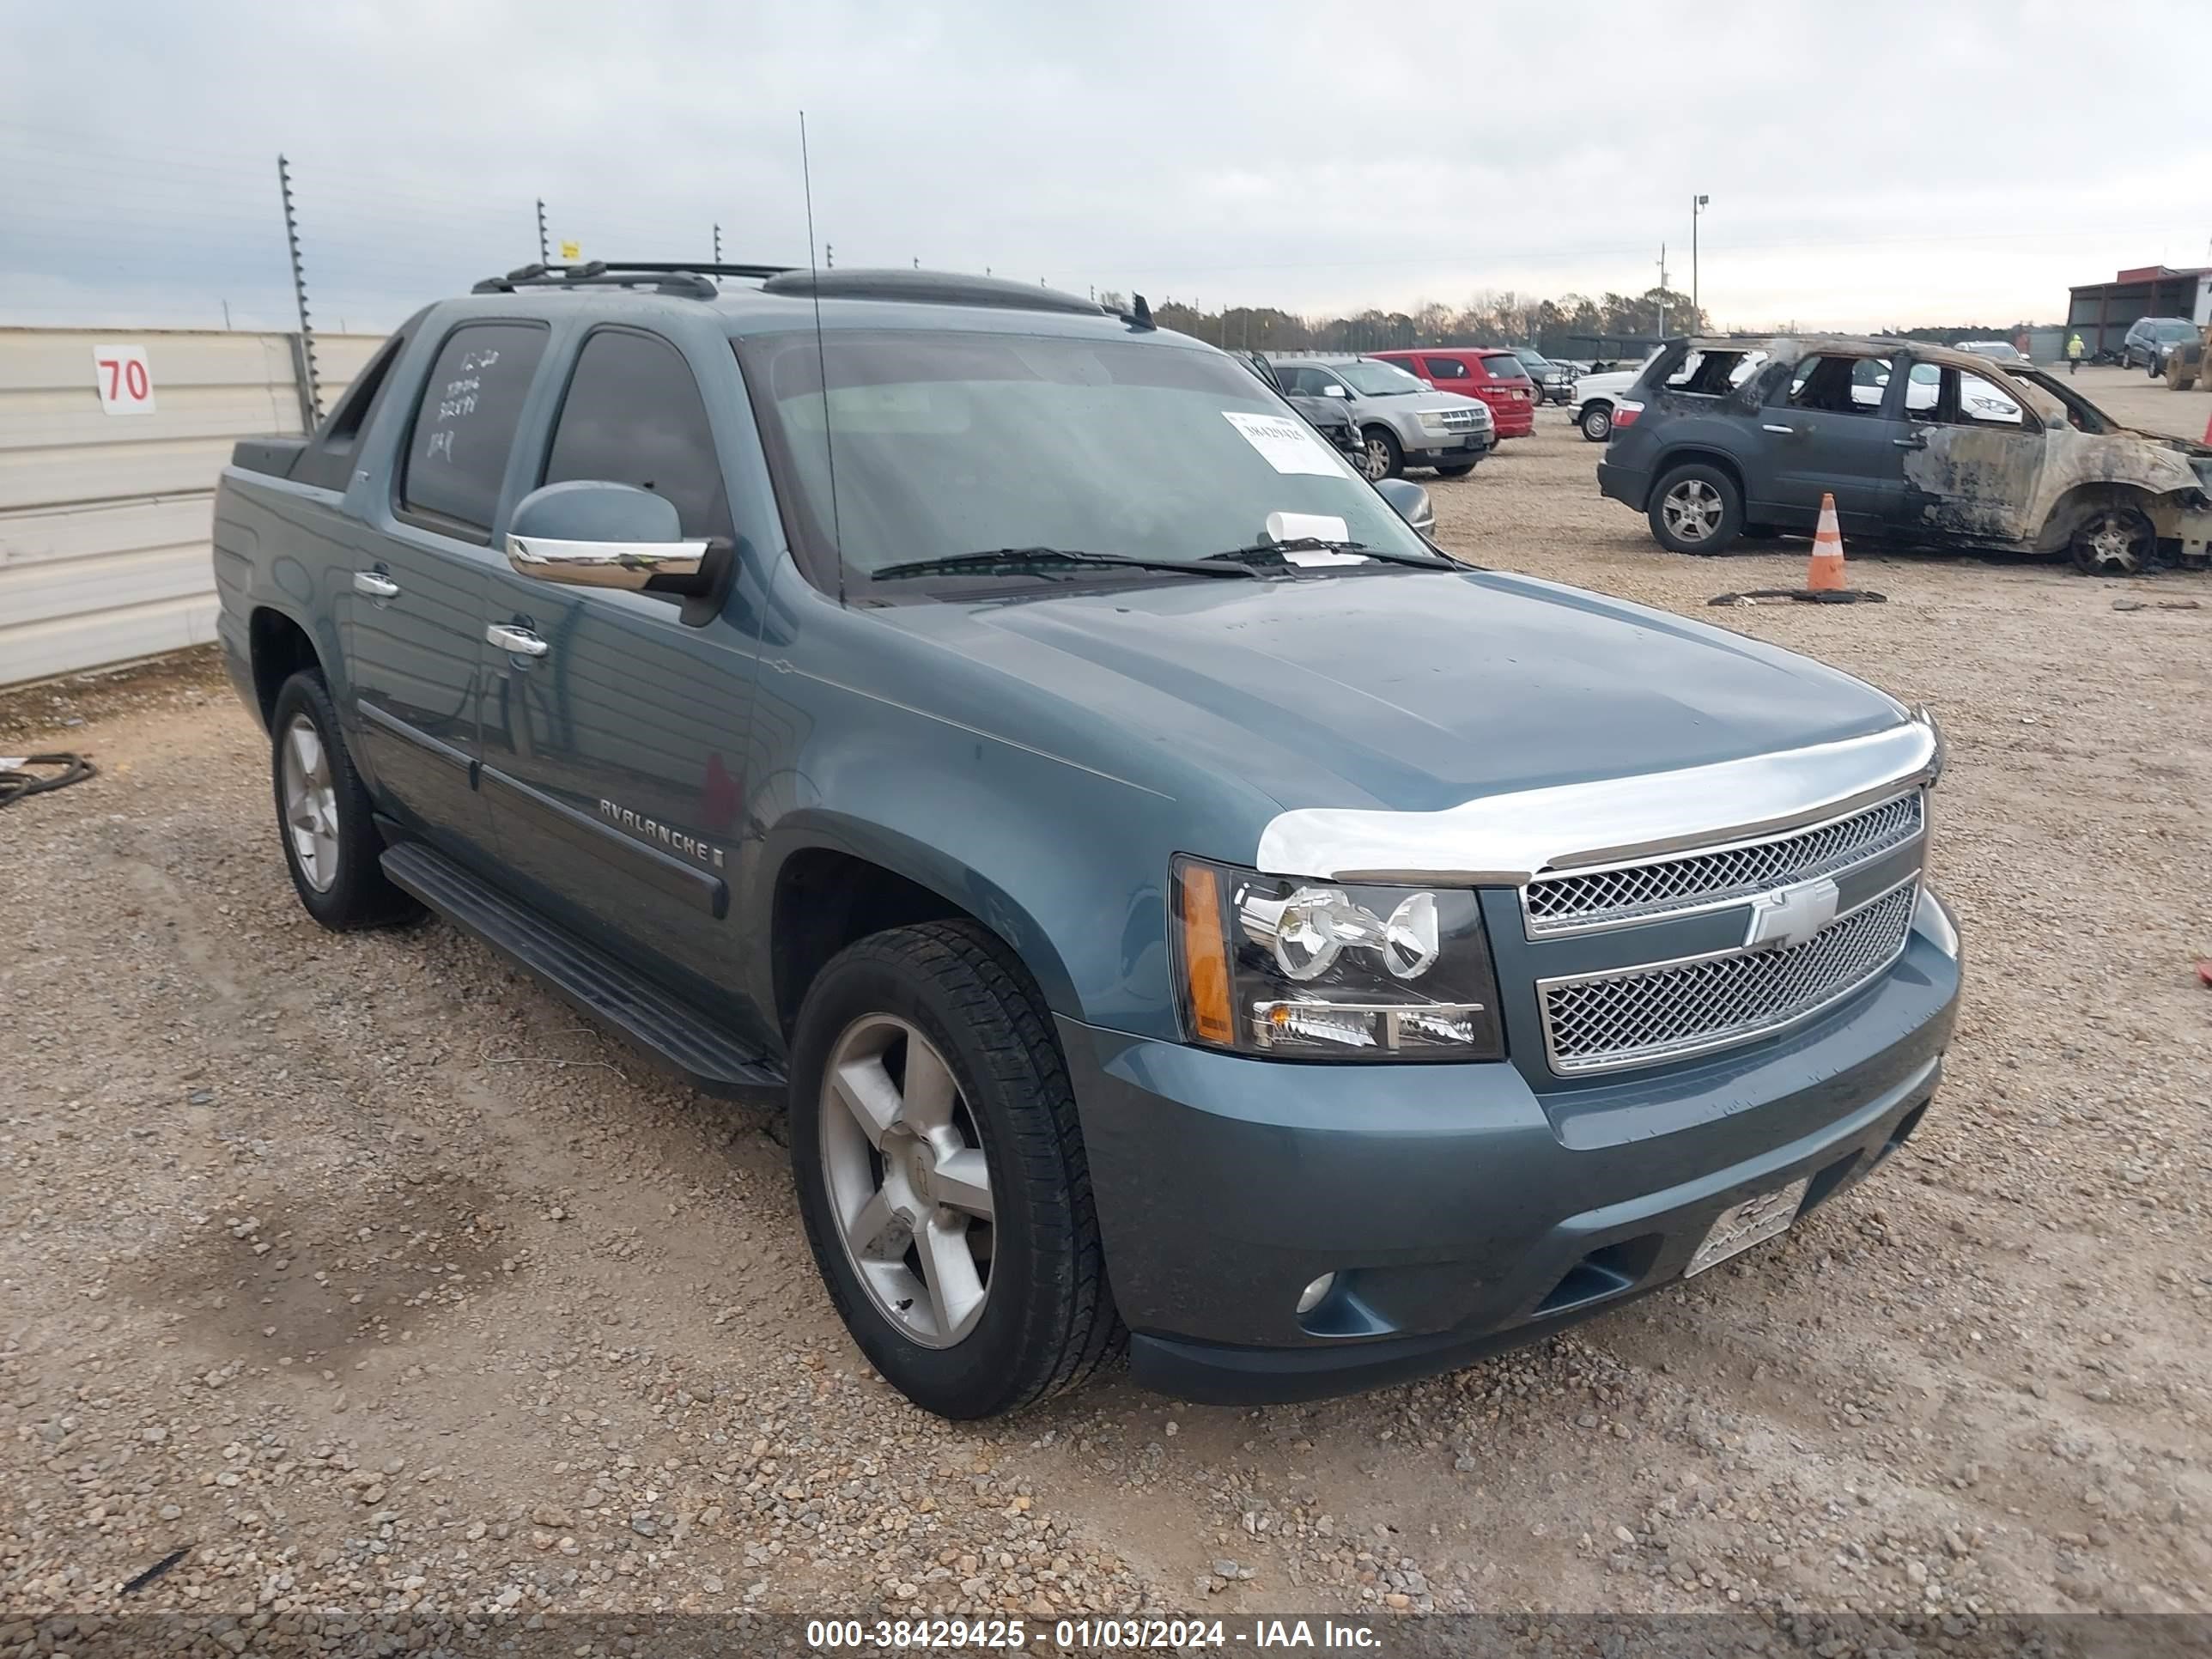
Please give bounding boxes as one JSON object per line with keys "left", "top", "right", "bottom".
{"left": 1256, "top": 710, "right": 1942, "bottom": 887}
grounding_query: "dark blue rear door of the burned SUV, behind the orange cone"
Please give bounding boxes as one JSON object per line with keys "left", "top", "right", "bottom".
{"left": 1745, "top": 352, "right": 1911, "bottom": 533}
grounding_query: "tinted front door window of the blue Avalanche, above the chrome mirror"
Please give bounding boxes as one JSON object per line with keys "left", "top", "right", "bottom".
{"left": 540, "top": 327, "right": 730, "bottom": 535}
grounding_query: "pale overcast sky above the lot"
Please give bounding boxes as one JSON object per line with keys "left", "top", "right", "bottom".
{"left": 0, "top": 0, "right": 2212, "bottom": 330}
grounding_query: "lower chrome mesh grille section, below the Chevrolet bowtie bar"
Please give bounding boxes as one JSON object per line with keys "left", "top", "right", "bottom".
{"left": 1535, "top": 876, "right": 1920, "bottom": 1078}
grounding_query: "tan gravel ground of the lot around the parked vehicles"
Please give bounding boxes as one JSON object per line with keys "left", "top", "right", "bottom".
{"left": 0, "top": 374, "right": 2212, "bottom": 1650}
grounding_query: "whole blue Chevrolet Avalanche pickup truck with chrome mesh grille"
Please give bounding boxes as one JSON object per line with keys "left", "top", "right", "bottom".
{"left": 215, "top": 265, "right": 1958, "bottom": 1418}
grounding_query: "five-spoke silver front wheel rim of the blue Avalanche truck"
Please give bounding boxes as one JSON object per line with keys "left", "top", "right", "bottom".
{"left": 821, "top": 1013, "right": 994, "bottom": 1347}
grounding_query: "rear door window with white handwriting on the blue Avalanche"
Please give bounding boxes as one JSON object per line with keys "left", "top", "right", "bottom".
{"left": 400, "top": 323, "right": 546, "bottom": 542}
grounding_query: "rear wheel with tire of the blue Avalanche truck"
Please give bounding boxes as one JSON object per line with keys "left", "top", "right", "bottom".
{"left": 270, "top": 668, "right": 422, "bottom": 933}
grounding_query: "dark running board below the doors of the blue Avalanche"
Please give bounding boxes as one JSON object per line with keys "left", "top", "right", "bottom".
{"left": 383, "top": 841, "right": 785, "bottom": 1106}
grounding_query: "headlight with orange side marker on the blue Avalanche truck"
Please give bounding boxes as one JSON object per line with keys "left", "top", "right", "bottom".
{"left": 1172, "top": 858, "right": 1504, "bottom": 1060}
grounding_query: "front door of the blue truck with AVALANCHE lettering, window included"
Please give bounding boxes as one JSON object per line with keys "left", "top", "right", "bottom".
{"left": 483, "top": 325, "right": 775, "bottom": 1037}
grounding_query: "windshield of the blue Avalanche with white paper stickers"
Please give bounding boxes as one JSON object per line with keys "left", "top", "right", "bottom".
{"left": 738, "top": 330, "right": 1427, "bottom": 580}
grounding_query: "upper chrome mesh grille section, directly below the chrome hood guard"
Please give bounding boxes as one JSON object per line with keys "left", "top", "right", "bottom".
{"left": 1522, "top": 790, "right": 1927, "bottom": 940}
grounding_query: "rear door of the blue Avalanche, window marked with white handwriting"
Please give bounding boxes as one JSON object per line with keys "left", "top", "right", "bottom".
{"left": 338, "top": 321, "right": 549, "bottom": 863}
